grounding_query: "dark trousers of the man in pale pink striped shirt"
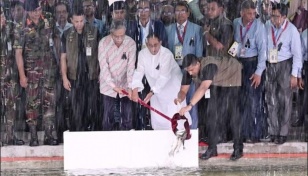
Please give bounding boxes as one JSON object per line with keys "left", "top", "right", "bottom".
{"left": 101, "top": 94, "right": 133, "bottom": 131}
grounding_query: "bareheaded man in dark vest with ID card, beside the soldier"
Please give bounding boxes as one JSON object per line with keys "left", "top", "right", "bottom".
{"left": 61, "top": 7, "right": 99, "bottom": 131}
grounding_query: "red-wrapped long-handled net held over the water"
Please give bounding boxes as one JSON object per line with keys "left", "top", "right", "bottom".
{"left": 122, "top": 90, "right": 191, "bottom": 140}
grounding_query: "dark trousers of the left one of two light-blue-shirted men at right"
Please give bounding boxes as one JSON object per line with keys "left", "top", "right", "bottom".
{"left": 239, "top": 57, "right": 266, "bottom": 139}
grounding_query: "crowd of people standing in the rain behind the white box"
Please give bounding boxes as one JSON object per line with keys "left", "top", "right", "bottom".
{"left": 0, "top": 0, "right": 308, "bottom": 160}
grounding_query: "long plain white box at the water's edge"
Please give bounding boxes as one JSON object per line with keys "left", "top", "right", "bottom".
{"left": 64, "top": 130, "right": 199, "bottom": 170}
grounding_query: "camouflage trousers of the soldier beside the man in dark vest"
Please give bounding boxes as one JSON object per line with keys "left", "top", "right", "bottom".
{"left": 25, "top": 58, "right": 56, "bottom": 127}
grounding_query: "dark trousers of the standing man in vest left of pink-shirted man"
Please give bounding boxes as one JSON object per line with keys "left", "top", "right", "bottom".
{"left": 64, "top": 79, "right": 98, "bottom": 131}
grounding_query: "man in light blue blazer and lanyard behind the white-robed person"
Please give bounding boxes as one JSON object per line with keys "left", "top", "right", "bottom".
{"left": 167, "top": 1, "right": 203, "bottom": 129}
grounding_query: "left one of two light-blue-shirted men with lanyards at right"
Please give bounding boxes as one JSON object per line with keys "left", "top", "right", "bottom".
{"left": 233, "top": 0, "right": 266, "bottom": 143}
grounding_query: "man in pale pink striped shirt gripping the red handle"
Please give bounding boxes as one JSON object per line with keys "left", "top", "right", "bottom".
{"left": 98, "top": 20, "right": 136, "bottom": 131}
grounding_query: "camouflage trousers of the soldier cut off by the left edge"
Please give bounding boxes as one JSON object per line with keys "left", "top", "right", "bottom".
{"left": 0, "top": 56, "right": 21, "bottom": 126}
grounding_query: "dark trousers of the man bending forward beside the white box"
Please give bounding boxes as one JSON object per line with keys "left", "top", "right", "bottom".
{"left": 206, "top": 86, "right": 243, "bottom": 149}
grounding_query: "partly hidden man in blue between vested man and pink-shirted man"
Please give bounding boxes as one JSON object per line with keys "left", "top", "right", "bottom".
{"left": 82, "top": 0, "right": 107, "bottom": 37}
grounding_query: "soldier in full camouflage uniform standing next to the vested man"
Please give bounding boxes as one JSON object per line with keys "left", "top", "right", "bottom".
{"left": 14, "top": 0, "right": 58, "bottom": 146}
